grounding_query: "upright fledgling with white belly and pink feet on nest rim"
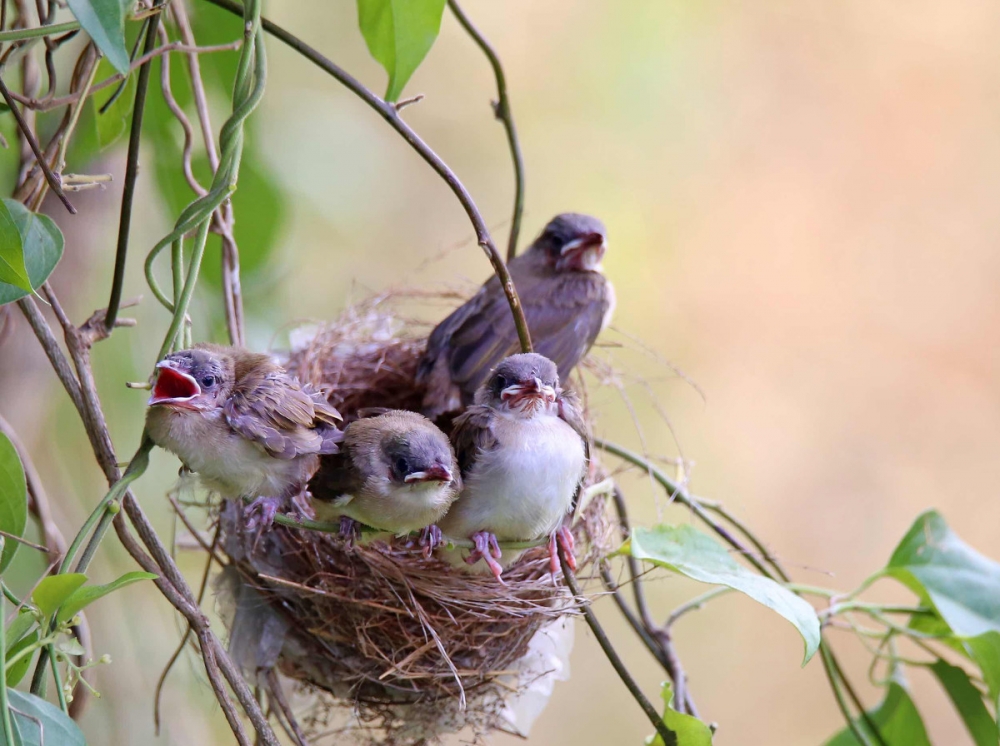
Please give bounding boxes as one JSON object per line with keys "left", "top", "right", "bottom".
{"left": 440, "top": 353, "right": 587, "bottom": 582}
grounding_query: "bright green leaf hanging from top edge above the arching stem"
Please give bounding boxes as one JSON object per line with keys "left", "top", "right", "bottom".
{"left": 358, "top": 0, "right": 445, "bottom": 101}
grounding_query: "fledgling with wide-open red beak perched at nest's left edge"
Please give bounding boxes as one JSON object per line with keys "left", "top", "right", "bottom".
{"left": 146, "top": 344, "right": 343, "bottom": 528}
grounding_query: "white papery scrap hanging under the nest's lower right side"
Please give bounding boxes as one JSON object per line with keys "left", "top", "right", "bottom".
{"left": 500, "top": 616, "right": 574, "bottom": 738}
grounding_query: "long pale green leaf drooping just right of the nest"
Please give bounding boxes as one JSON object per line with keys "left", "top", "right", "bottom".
{"left": 617, "top": 524, "right": 820, "bottom": 665}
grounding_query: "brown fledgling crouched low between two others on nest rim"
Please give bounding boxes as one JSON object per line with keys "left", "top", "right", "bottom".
{"left": 309, "top": 410, "right": 462, "bottom": 556}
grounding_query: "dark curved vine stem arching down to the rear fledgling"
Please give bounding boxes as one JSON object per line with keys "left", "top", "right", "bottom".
{"left": 199, "top": 0, "right": 531, "bottom": 352}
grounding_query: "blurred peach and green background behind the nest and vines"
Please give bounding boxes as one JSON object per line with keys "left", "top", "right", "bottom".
{"left": 0, "top": 0, "right": 1000, "bottom": 746}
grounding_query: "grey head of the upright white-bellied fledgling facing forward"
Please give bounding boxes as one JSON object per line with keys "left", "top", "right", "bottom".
{"left": 476, "top": 352, "right": 560, "bottom": 417}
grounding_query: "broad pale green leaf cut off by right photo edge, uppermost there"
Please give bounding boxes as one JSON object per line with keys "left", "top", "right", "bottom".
{"left": 880, "top": 510, "right": 1000, "bottom": 637}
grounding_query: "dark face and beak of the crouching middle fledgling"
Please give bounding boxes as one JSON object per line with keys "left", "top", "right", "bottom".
{"left": 382, "top": 415, "right": 459, "bottom": 487}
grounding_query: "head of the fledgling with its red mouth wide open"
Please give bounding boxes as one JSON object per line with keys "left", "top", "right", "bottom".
{"left": 149, "top": 348, "right": 233, "bottom": 411}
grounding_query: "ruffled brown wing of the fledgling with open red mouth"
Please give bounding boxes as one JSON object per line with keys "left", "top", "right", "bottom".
{"left": 223, "top": 370, "right": 340, "bottom": 459}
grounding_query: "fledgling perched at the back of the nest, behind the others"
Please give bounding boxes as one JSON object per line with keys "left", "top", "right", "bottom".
{"left": 417, "top": 213, "right": 615, "bottom": 419}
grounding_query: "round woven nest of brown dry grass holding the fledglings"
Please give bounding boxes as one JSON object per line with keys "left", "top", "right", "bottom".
{"left": 220, "top": 297, "right": 612, "bottom": 744}
